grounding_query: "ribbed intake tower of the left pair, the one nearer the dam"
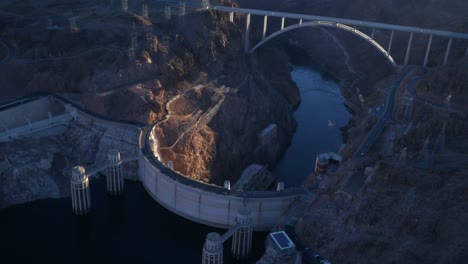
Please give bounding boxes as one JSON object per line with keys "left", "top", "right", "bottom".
{"left": 107, "top": 149, "right": 124, "bottom": 195}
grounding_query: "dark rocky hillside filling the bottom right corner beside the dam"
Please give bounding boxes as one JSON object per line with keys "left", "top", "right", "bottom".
{"left": 296, "top": 162, "right": 468, "bottom": 263}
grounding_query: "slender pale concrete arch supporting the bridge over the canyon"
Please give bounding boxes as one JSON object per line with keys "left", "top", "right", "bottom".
{"left": 247, "top": 21, "right": 398, "bottom": 67}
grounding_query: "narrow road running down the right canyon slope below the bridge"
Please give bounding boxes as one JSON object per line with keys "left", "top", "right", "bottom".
{"left": 353, "top": 66, "right": 411, "bottom": 157}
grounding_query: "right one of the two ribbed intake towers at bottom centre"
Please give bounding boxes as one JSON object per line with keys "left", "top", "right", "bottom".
{"left": 231, "top": 207, "right": 252, "bottom": 260}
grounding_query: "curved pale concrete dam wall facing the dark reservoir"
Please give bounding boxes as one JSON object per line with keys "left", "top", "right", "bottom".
{"left": 138, "top": 127, "right": 316, "bottom": 230}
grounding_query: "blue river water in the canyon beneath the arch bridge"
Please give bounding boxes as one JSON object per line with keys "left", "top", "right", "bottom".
{"left": 274, "top": 66, "right": 351, "bottom": 188}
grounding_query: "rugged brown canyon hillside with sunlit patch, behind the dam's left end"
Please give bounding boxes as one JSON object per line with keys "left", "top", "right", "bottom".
{"left": 0, "top": 1, "right": 300, "bottom": 184}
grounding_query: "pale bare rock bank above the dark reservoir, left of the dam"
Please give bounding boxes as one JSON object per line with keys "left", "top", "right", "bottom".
{"left": 0, "top": 119, "right": 140, "bottom": 208}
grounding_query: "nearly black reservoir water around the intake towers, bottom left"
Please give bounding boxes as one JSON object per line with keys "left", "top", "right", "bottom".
{"left": 0, "top": 179, "right": 266, "bottom": 264}
